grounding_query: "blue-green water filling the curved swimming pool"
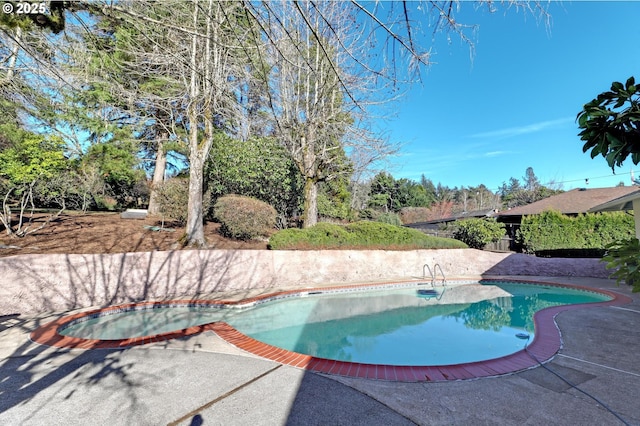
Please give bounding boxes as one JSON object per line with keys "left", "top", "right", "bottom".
{"left": 61, "top": 283, "right": 609, "bottom": 365}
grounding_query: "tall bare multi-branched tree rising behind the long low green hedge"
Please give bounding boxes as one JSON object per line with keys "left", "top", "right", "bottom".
{"left": 253, "top": 1, "right": 404, "bottom": 227}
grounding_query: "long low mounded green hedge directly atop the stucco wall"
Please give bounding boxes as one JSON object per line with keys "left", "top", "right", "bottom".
{"left": 269, "top": 221, "right": 467, "bottom": 250}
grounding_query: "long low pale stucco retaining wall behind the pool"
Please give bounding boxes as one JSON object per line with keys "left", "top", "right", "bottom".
{"left": 0, "top": 249, "right": 608, "bottom": 315}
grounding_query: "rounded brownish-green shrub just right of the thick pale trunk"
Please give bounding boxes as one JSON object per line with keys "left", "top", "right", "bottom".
{"left": 213, "top": 195, "right": 276, "bottom": 240}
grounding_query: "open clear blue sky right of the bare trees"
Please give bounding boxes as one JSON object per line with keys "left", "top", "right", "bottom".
{"left": 385, "top": 1, "right": 640, "bottom": 192}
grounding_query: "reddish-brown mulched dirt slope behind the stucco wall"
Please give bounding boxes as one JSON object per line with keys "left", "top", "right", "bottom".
{"left": 0, "top": 212, "right": 267, "bottom": 257}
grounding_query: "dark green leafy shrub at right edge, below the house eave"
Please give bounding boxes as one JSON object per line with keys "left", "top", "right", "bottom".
{"left": 602, "top": 237, "right": 640, "bottom": 293}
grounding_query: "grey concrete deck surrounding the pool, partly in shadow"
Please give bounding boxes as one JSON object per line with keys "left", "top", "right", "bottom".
{"left": 0, "top": 276, "right": 640, "bottom": 425}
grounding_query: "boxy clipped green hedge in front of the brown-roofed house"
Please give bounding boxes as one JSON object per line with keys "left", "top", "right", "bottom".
{"left": 517, "top": 210, "right": 635, "bottom": 253}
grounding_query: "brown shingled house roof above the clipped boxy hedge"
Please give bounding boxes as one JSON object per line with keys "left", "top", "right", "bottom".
{"left": 496, "top": 186, "right": 640, "bottom": 217}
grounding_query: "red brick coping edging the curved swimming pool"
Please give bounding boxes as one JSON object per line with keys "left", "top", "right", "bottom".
{"left": 30, "top": 279, "right": 632, "bottom": 382}
